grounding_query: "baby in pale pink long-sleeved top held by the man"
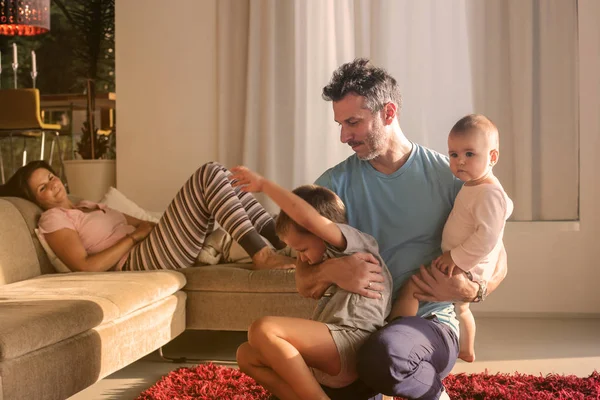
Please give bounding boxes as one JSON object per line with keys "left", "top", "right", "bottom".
{"left": 389, "top": 114, "right": 513, "bottom": 362}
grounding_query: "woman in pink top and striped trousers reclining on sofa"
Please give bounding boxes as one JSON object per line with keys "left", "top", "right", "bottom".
{"left": 0, "top": 161, "right": 294, "bottom": 272}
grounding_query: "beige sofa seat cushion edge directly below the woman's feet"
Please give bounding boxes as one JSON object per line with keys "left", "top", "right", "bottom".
{"left": 181, "top": 264, "right": 297, "bottom": 293}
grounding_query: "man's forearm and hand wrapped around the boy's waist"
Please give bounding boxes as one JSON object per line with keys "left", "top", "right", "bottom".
{"left": 296, "top": 253, "right": 384, "bottom": 299}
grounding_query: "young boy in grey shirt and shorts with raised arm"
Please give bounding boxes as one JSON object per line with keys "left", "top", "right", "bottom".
{"left": 231, "top": 167, "right": 392, "bottom": 400}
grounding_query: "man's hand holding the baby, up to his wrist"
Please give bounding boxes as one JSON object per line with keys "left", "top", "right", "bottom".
{"left": 411, "top": 265, "right": 479, "bottom": 303}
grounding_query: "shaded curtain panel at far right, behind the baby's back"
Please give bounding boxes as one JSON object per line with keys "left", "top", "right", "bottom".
{"left": 468, "top": 0, "right": 579, "bottom": 221}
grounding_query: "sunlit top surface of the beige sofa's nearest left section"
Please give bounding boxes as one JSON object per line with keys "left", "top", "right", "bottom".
{"left": 0, "top": 271, "right": 185, "bottom": 360}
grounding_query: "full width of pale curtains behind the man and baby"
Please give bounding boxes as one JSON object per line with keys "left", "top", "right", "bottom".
{"left": 217, "top": 0, "right": 578, "bottom": 220}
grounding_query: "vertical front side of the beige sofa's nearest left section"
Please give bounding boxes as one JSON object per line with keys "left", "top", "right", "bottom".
{"left": 0, "top": 291, "right": 186, "bottom": 400}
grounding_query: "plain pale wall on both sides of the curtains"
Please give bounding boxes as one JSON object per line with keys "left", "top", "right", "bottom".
{"left": 116, "top": 0, "right": 600, "bottom": 314}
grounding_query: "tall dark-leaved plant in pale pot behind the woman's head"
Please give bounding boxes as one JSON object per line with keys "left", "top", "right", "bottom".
{"left": 55, "top": 0, "right": 116, "bottom": 201}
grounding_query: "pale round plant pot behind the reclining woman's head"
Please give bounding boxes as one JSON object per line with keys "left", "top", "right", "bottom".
{"left": 64, "top": 160, "right": 117, "bottom": 201}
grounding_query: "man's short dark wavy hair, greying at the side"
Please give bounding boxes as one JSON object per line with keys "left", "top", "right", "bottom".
{"left": 323, "top": 58, "right": 402, "bottom": 113}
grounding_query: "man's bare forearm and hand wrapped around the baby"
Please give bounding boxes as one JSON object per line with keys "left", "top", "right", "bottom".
{"left": 412, "top": 246, "right": 508, "bottom": 303}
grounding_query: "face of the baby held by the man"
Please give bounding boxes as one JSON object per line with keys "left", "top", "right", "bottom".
{"left": 448, "top": 132, "right": 495, "bottom": 182}
